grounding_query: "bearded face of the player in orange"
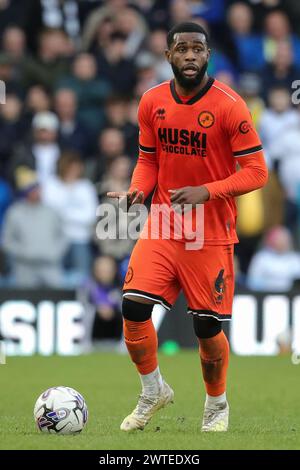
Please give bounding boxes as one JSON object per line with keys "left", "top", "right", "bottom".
{"left": 166, "top": 33, "right": 210, "bottom": 90}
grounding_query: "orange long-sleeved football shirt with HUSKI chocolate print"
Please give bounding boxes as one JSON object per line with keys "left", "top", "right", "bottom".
{"left": 130, "top": 78, "right": 267, "bottom": 245}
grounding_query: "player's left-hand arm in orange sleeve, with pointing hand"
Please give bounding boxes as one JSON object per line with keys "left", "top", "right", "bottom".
{"left": 107, "top": 96, "right": 158, "bottom": 205}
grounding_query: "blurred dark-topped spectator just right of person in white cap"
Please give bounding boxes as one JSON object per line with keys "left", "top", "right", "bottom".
{"left": 54, "top": 88, "right": 93, "bottom": 159}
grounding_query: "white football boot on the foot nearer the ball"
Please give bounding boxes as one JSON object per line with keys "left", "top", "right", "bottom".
{"left": 120, "top": 382, "right": 174, "bottom": 431}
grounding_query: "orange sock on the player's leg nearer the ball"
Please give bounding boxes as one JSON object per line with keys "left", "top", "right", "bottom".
{"left": 123, "top": 318, "right": 158, "bottom": 375}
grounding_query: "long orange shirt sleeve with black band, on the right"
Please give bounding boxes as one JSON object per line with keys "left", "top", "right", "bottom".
{"left": 205, "top": 99, "right": 268, "bottom": 199}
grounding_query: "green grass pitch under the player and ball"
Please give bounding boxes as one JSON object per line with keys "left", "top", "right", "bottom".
{"left": 0, "top": 350, "right": 300, "bottom": 450}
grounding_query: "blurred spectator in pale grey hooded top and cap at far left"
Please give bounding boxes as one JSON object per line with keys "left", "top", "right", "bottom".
{"left": 3, "top": 167, "right": 66, "bottom": 288}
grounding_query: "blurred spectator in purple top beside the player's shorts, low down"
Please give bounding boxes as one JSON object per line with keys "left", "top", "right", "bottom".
{"left": 80, "top": 256, "right": 122, "bottom": 349}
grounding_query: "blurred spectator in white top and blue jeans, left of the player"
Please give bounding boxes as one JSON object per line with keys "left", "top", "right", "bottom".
{"left": 43, "top": 152, "right": 98, "bottom": 287}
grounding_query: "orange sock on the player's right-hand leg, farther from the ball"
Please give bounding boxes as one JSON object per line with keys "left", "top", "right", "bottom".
{"left": 198, "top": 331, "right": 229, "bottom": 397}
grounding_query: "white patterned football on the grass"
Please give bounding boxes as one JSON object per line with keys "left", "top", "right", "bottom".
{"left": 33, "top": 386, "right": 88, "bottom": 435}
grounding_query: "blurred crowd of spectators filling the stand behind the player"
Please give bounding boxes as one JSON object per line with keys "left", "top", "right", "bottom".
{"left": 0, "top": 0, "right": 300, "bottom": 342}
